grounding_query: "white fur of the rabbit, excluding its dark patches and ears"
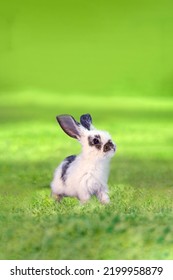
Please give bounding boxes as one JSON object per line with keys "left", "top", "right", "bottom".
{"left": 51, "top": 115, "right": 115, "bottom": 203}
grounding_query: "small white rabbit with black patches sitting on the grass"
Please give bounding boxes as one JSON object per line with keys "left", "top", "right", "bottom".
{"left": 51, "top": 114, "right": 116, "bottom": 204}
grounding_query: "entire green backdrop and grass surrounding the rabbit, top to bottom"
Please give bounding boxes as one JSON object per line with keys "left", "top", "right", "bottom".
{"left": 0, "top": 0, "right": 173, "bottom": 259}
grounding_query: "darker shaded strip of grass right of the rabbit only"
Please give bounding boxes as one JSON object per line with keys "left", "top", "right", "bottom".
{"left": 110, "top": 157, "right": 173, "bottom": 187}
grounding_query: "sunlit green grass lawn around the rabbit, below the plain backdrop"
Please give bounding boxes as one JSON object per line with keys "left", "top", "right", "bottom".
{"left": 0, "top": 91, "right": 173, "bottom": 259}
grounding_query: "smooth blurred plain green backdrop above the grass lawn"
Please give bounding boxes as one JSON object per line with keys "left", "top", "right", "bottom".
{"left": 0, "top": 0, "right": 173, "bottom": 96}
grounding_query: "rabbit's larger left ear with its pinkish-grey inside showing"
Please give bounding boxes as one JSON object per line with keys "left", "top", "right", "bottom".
{"left": 56, "top": 115, "right": 80, "bottom": 139}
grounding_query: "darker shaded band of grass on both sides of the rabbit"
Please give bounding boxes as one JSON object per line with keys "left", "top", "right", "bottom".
{"left": 0, "top": 157, "right": 173, "bottom": 196}
